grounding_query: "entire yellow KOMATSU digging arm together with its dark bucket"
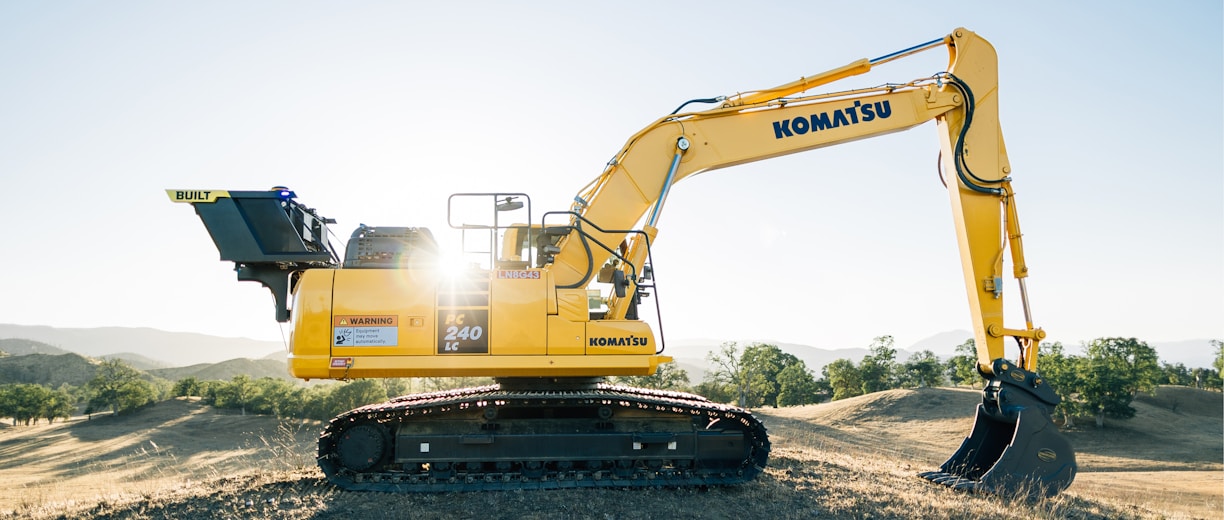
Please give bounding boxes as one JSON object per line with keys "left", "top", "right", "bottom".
{"left": 550, "top": 28, "right": 1076, "bottom": 494}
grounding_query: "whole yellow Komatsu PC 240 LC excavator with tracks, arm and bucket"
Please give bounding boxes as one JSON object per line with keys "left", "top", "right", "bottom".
{"left": 166, "top": 28, "right": 1076, "bottom": 497}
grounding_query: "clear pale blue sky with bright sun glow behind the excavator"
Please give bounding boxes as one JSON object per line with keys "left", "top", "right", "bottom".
{"left": 0, "top": 0, "right": 1224, "bottom": 349}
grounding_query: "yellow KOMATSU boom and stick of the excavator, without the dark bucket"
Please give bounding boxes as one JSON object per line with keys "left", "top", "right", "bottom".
{"left": 551, "top": 29, "right": 1044, "bottom": 373}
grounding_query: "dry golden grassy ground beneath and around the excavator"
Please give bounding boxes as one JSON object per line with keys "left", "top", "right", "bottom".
{"left": 0, "top": 388, "right": 1224, "bottom": 520}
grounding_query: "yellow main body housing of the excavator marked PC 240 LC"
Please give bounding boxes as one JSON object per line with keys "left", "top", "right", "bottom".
{"left": 289, "top": 269, "right": 670, "bottom": 379}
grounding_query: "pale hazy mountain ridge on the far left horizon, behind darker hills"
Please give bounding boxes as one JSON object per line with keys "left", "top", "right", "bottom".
{"left": 0, "top": 324, "right": 284, "bottom": 366}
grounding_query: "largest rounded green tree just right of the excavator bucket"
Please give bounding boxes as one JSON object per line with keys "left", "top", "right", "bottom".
{"left": 1080, "top": 338, "right": 1160, "bottom": 428}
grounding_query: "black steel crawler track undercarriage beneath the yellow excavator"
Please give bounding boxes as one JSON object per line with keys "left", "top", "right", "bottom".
{"left": 318, "top": 383, "right": 770, "bottom": 493}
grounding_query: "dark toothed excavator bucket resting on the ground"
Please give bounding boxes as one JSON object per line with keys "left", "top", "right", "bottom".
{"left": 919, "top": 360, "right": 1077, "bottom": 498}
